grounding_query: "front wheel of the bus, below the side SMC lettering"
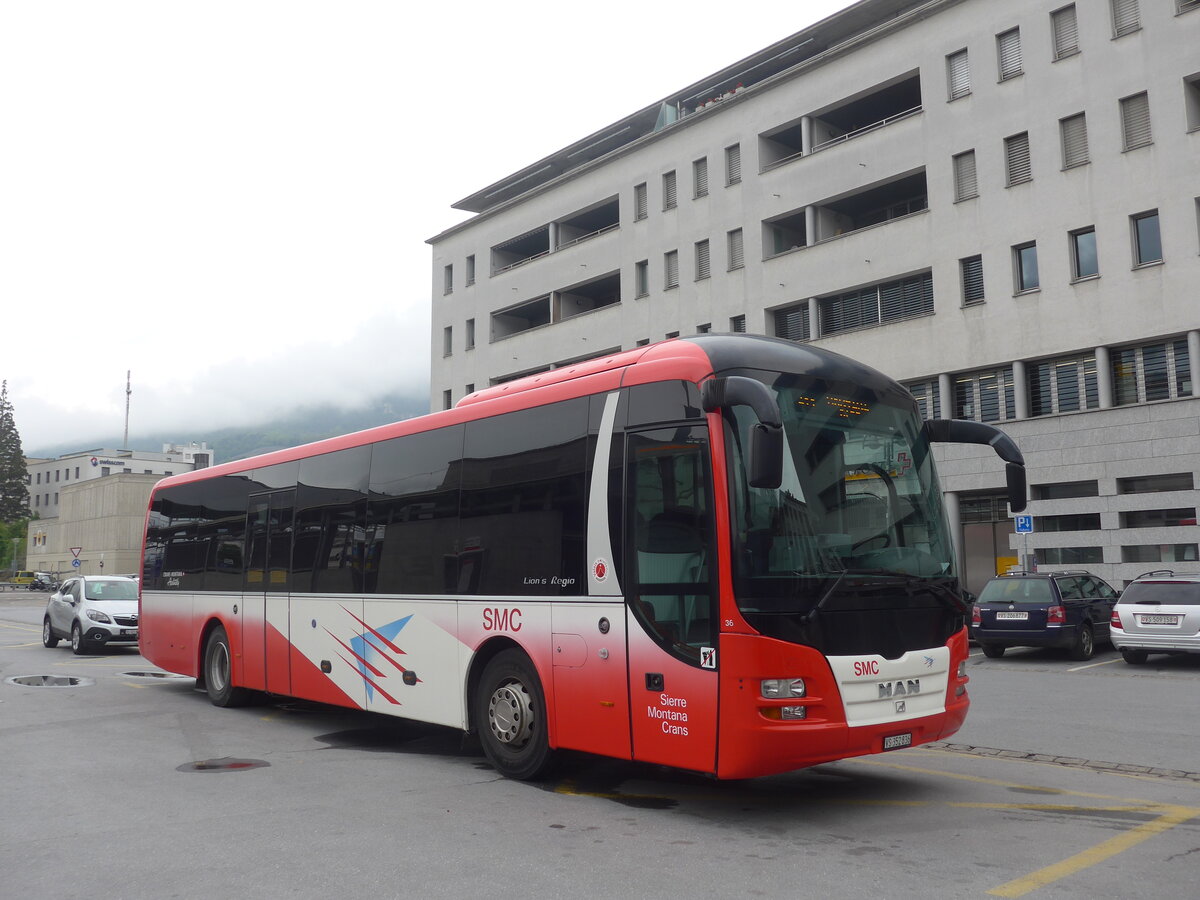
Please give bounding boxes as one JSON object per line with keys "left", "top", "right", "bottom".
{"left": 474, "top": 649, "right": 554, "bottom": 781}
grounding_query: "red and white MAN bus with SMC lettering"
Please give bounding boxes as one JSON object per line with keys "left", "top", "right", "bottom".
{"left": 140, "top": 335, "right": 1025, "bottom": 779}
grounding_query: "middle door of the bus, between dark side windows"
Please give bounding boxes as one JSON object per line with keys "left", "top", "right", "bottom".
{"left": 240, "top": 490, "right": 296, "bottom": 694}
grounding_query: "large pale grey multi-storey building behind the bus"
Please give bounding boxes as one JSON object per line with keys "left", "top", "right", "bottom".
{"left": 430, "top": 0, "right": 1200, "bottom": 588}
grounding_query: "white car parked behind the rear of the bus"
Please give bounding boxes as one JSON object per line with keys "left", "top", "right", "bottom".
{"left": 42, "top": 575, "right": 138, "bottom": 654}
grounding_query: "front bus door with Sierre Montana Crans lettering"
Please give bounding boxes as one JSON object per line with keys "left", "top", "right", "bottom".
{"left": 625, "top": 426, "right": 718, "bottom": 772}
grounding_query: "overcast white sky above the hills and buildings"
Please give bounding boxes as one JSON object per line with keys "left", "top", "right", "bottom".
{"left": 0, "top": 0, "right": 850, "bottom": 452}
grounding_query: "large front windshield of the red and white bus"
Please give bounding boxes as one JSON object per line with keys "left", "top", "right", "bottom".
{"left": 726, "top": 374, "right": 959, "bottom": 657}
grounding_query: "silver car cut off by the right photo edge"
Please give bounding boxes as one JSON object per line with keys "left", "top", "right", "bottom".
{"left": 1109, "top": 570, "right": 1200, "bottom": 665}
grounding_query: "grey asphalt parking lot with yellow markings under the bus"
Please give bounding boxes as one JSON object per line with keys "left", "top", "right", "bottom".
{"left": 0, "top": 598, "right": 1200, "bottom": 898}
